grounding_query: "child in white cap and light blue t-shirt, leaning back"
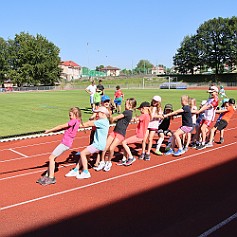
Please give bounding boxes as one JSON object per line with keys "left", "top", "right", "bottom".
{"left": 65, "top": 106, "right": 109, "bottom": 179}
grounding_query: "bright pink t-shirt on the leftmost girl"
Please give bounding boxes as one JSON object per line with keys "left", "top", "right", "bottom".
{"left": 61, "top": 119, "right": 81, "bottom": 147}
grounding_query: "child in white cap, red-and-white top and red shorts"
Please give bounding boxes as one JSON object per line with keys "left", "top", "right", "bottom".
{"left": 196, "top": 86, "right": 218, "bottom": 150}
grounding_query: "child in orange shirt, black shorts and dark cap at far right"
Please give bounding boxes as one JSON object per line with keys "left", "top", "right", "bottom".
{"left": 206, "top": 98, "right": 236, "bottom": 147}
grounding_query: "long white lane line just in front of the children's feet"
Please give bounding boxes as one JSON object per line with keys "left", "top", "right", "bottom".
{"left": 0, "top": 142, "right": 237, "bottom": 211}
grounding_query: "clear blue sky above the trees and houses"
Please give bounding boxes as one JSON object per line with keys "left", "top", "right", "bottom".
{"left": 0, "top": 0, "right": 237, "bottom": 69}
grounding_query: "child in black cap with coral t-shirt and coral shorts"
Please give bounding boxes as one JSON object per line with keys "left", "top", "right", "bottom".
{"left": 120, "top": 101, "right": 151, "bottom": 166}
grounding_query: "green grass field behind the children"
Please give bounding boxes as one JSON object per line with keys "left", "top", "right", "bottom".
{"left": 0, "top": 89, "right": 237, "bottom": 137}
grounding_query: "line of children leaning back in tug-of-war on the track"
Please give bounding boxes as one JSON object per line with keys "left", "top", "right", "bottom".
{"left": 37, "top": 86, "right": 236, "bottom": 186}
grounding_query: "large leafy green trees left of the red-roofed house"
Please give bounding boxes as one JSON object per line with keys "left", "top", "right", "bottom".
{"left": 0, "top": 32, "right": 61, "bottom": 87}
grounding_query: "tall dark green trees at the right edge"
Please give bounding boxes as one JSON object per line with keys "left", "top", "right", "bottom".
{"left": 173, "top": 17, "right": 237, "bottom": 74}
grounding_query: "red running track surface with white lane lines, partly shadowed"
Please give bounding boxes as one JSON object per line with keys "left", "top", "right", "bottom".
{"left": 0, "top": 113, "right": 237, "bottom": 237}
